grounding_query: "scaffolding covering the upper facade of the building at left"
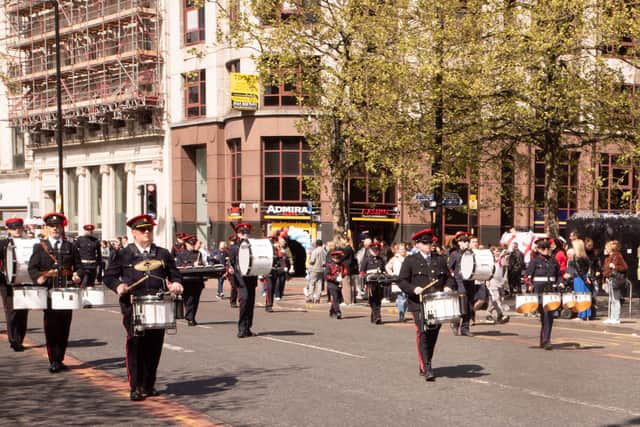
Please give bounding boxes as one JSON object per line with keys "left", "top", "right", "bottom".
{"left": 4, "top": 0, "right": 163, "bottom": 144}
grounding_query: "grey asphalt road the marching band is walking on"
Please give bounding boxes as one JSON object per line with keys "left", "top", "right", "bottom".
{"left": 0, "top": 289, "right": 640, "bottom": 426}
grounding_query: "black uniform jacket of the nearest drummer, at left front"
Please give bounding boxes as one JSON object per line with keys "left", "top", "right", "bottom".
{"left": 102, "top": 243, "right": 182, "bottom": 303}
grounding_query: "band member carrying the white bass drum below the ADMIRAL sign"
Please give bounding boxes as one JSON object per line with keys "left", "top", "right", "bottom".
{"left": 229, "top": 223, "right": 258, "bottom": 338}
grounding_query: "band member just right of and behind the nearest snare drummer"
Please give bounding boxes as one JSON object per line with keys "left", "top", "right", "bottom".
{"left": 176, "top": 234, "right": 204, "bottom": 326}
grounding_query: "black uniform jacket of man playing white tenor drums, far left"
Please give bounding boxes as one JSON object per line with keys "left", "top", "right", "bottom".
{"left": 29, "top": 239, "right": 84, "bottom": 287}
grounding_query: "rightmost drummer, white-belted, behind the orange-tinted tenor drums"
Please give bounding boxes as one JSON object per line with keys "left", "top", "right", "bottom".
{"left": 525, "top": 238, "right": 563, "bottom": 350}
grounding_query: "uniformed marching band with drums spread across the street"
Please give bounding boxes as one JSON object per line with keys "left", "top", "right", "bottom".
{"left": 0, "top": 212, "right": 604, "bottom": 401}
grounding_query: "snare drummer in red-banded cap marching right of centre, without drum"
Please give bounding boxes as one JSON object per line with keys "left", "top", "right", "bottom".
{"left": 398, "top": 228, "right": 455, "bottom": 381}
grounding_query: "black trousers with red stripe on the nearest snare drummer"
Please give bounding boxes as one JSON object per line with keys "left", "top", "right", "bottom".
{"left": 123, "top": 306, "right": 164, "bottom": 390}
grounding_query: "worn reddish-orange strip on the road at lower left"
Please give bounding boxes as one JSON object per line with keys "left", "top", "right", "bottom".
{"left": 0, "top": 334, "right": 224, "bottom": 427}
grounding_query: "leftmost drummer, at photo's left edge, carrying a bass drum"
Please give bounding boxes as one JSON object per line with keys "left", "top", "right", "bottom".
{"left": 0, "top": 218, "right": 29, "bottom": 351}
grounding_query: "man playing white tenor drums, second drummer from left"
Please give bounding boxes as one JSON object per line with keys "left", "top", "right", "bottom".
{"left": 29, "top": 212, "right": 84, "bottom": 373}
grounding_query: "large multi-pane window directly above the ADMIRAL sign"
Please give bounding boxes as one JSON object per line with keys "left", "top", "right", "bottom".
{"left": 262, "top": 136, "right": 313, "bottom": 202}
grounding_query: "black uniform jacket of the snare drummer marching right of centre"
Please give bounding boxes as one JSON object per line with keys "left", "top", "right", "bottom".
{"left": 398, "top": 252, "right": 455, "bottom": 312}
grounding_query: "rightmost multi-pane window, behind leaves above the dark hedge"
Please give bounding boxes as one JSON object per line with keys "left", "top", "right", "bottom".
{"left": 598, "top": 153, "right": 638, "bottom": 212}
